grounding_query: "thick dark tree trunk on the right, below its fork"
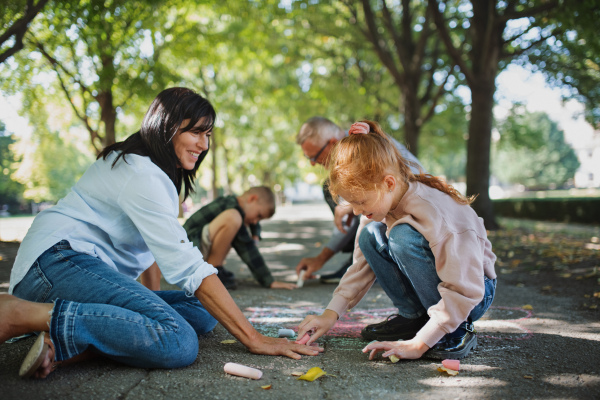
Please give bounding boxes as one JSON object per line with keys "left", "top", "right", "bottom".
{"left": 467, "top": 77, "right": 499, "bottom": 230}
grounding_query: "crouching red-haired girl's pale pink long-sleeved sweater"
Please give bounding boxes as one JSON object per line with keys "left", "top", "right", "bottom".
{"left": 327, "top": 182, "right": 496, "bottom": 347}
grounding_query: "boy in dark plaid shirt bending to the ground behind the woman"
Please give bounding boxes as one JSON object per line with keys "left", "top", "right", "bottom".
{"left": 183, "top": 186, "right": 296, "bottom": 290}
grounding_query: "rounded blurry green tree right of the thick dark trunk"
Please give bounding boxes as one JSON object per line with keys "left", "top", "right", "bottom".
{"left": 492, "top": 106, "right": 579, "bottom": 189}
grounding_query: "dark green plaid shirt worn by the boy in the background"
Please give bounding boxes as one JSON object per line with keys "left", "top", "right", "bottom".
{"left": 183, "top": 195, "right": 274, "bottom": 287}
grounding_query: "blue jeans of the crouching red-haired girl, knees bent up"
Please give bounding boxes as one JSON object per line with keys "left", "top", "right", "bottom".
{"left": 358, "top": 222, "right": 496, "bottom": 321}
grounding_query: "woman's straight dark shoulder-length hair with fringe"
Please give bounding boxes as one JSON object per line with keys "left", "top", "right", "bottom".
{"left": 98, "top": 87, "right": 216, "bottom": 199}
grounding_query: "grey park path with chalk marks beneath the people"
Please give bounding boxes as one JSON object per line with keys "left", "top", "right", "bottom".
{"left": 0, "top": 203, "right": 600, "bottom": 400}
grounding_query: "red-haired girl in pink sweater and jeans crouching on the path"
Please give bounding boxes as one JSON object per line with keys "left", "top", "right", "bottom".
{"left": 298, "top": 121, "right": 496, "bottom": 359}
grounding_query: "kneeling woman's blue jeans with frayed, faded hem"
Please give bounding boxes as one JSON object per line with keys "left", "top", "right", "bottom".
{"left": 14, "top": 240, "right": 217, "bottom": 368}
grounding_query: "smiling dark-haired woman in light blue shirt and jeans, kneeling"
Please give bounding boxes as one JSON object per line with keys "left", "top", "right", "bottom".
{"left": 0, "top": 88, "right": 318, "bottom": 378}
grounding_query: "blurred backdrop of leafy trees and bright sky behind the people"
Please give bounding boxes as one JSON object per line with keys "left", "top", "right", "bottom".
{"left": 0, "top": 0, "right": 600, "bottom": 229}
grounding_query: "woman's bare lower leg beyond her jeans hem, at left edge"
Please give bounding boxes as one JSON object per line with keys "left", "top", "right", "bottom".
{"left": 0, "top": 293, "right": 54, "bottom": 344}
